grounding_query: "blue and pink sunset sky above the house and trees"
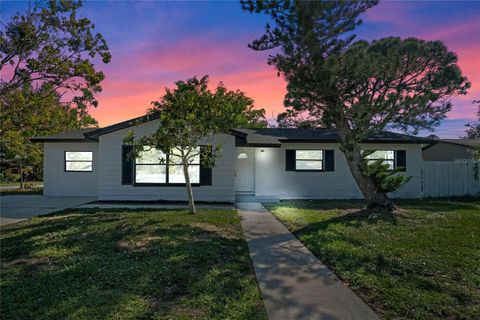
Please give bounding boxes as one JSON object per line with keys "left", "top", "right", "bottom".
{"left": 1, "top": 1, "right": 480, "bottom": 137}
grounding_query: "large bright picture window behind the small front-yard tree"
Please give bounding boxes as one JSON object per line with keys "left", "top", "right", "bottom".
{"left": 135, "top": 147, "right": 200, "bottom": 184}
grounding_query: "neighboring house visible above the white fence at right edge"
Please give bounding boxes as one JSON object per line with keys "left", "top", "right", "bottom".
{"left": 422, "top": 139, "right": 480, "bottom": 161}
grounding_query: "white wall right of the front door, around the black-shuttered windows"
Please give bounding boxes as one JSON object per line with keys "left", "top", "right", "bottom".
{"left": 255, "top": 143, "right": 422, "bottom": 199}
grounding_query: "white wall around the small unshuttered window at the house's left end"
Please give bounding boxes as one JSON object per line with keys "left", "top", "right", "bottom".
{"left": 43, "top": 142, "right": 99, "bottom": 196}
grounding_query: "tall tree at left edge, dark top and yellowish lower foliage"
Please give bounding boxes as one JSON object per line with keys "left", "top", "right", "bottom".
{"left": 0, "top": 0, "right": 111, "bottom": 188}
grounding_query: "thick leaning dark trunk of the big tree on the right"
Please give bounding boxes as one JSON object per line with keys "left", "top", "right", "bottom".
{"left": 337, "top": 117, "right": 395, "bottom": 212}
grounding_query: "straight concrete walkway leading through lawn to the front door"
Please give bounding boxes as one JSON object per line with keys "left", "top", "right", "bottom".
{"left": 237, "top": 203, "right": 378, "bottom": 320}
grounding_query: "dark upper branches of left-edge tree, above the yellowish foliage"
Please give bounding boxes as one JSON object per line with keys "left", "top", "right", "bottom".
{"left": 0, "top": 0, "right": 111, "bottom": 113}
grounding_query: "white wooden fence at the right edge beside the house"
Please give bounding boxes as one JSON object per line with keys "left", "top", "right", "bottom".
{"left": 422, "top": 160, "right": 480, "bottom": 198}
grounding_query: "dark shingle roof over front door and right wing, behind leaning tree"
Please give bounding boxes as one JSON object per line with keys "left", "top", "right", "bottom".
{"left": 232, "top": 128, "right": 430, "bottom": 146}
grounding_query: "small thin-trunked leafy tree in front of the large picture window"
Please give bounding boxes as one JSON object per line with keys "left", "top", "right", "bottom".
{"left": 125, "top": 76, "right": 267, "bottom": 213}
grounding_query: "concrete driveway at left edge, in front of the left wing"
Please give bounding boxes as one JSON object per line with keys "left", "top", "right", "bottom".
{"left": 0, "top": 195, "right": 96, "bottom": 225}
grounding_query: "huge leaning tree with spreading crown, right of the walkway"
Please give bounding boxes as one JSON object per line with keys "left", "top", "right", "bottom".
{"left": 242, "top": 0, "right": 470, "bottom": 210}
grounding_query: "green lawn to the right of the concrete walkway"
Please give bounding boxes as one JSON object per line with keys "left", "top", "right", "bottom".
{"left": 266, "top": 199, "right": 480, "bottom": 319}
